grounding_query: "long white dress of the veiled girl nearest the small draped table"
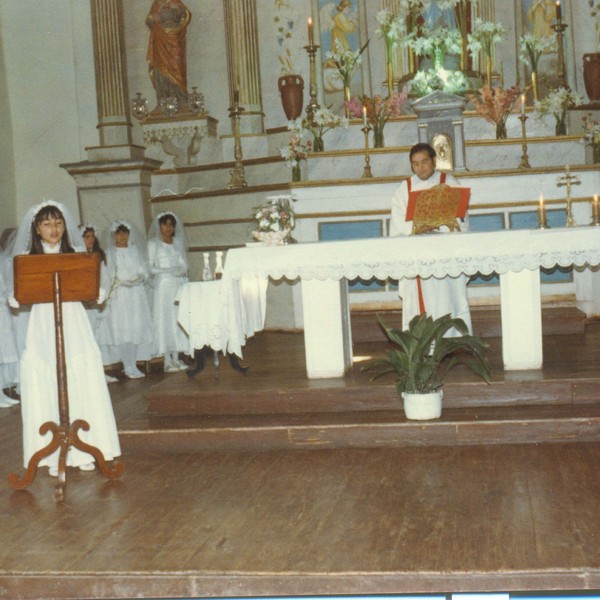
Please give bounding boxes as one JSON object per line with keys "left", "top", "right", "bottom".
{"left": 148, "top": 238, "right": 189, "bottom": 355}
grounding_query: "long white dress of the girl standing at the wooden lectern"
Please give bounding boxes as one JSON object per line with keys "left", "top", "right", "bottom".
{"left": 21, "top": 246, "right": 121, "bottom": 467}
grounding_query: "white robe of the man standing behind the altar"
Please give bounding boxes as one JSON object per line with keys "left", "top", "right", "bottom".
{"left": 390, "top": 170, "right": 472, "bottom": 336}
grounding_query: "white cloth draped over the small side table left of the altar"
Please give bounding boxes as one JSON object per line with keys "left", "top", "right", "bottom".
{"left": 177, "top": 277, "right": 267, "bottom": 358}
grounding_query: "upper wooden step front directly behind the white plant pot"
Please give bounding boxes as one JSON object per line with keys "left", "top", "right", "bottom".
{"left": 147, "top": 372, "right": 600, "bottom": 417}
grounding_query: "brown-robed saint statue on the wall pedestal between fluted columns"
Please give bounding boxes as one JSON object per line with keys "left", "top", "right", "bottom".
{"left": 146, "top": 0, "right": 192, "bottom": 108}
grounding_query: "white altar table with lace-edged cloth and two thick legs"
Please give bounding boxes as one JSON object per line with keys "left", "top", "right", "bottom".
{"left": 223, "top": 226, "right": 600, "bottom": 378}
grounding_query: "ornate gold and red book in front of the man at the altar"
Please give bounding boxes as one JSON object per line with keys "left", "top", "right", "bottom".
{"left": 406, "top": 183, "right": 471, "bottom": 234}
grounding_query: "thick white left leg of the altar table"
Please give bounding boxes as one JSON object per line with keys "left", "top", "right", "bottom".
{"left": 302, "top": 279, "right": 352, "bottom": 379}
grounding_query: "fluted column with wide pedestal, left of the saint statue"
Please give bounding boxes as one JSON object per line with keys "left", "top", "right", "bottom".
{"left": 61, "top": 0, "right": 162, "bottom": 231}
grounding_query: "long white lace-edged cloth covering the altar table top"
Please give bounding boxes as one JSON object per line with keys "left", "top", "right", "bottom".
{"left": 219, "top": 227, "right": 600, "bottom": 280}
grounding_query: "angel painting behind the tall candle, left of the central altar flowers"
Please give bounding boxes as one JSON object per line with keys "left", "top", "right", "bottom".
{"left": 313, "top": 0, "right": 368, "bottom": 112}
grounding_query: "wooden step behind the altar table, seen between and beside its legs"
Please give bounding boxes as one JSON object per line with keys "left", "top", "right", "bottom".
{"left": 350, "top": 307, "right": 586, "bottom": 342}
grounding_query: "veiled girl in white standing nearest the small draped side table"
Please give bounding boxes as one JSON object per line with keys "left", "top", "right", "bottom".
{"left": 148, "top": 212, "right": 189, "bottom": 373}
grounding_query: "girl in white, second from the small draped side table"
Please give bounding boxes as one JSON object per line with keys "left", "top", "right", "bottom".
{"left": 99, "top": 220, "right": 153, "bottom": 379}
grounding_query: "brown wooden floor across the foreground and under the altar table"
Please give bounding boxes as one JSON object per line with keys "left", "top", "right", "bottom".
{"left": 0, "top": 323, "right": 600, "bottom": 598}
